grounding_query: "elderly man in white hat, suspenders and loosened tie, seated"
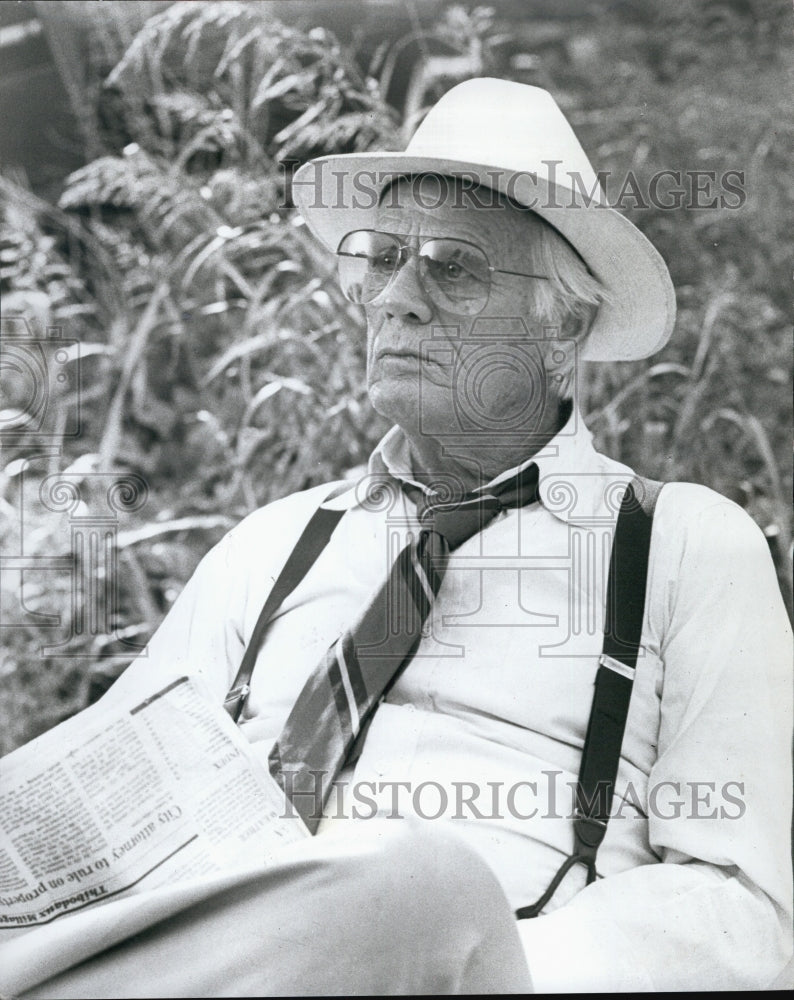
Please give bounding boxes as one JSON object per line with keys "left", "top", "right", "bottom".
{"left": 3, "top": 80, "right": 791, "bottom": 997}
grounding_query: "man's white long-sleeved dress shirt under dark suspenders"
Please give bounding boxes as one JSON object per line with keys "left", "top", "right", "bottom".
{"left": 109, "top": 411, "right": 792, "bottom": 992}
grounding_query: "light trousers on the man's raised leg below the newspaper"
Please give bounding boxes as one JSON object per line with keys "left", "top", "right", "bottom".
{"left": 0, "top": 820, "right": 532, "bottom": 1000}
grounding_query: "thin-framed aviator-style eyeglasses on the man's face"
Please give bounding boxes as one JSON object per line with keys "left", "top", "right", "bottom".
{"left": 336, "top": 229, "right": 548, "bottom": 316}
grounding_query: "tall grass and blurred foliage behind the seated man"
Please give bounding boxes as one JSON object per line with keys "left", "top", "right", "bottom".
{"left": 0, "top": 0, "right": 794, "bottom": 753}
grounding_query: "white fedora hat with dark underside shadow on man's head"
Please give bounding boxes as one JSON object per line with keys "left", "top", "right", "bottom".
{"left": 292, "top": 78, "right": 675, "bottom": 361}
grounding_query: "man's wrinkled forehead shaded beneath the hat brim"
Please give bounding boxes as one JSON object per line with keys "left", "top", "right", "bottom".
{"left": 376, "top": 174, "right": 541, "bottom": 244}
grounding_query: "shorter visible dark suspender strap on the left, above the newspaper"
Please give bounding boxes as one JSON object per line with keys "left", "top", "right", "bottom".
{"left": 223, "top": 484, "right": 348, "bottom": 722}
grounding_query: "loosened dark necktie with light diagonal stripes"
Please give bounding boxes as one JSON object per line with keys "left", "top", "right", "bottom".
{"left": 268, "top": 463, "right": 538, "bottom": 833}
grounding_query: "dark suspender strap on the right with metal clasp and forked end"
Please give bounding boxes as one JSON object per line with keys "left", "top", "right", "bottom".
{"left": 516, "top": 478, "right": 663, "bottom": 920}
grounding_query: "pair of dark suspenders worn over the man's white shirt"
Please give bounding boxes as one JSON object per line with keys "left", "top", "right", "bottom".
{"left": 224, "top": 477, "right": 663, "bottom": 920}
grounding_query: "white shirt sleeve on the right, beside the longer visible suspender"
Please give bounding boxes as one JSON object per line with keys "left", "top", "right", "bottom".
{"left": 518, "top": 485, "right": 792, "bottom": 992}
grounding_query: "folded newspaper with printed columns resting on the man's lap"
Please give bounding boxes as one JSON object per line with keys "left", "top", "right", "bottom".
{"left": 0, "top": 677, "right": 309, "bottom": 928}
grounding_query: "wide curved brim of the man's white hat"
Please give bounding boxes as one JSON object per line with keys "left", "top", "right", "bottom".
{"left": 292, "top": 152, "right": 675, "bottom": 361}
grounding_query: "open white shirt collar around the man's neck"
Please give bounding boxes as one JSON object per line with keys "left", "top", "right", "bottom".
{"left": 324, "top": 407, "right": 634, "bottom": 526}
